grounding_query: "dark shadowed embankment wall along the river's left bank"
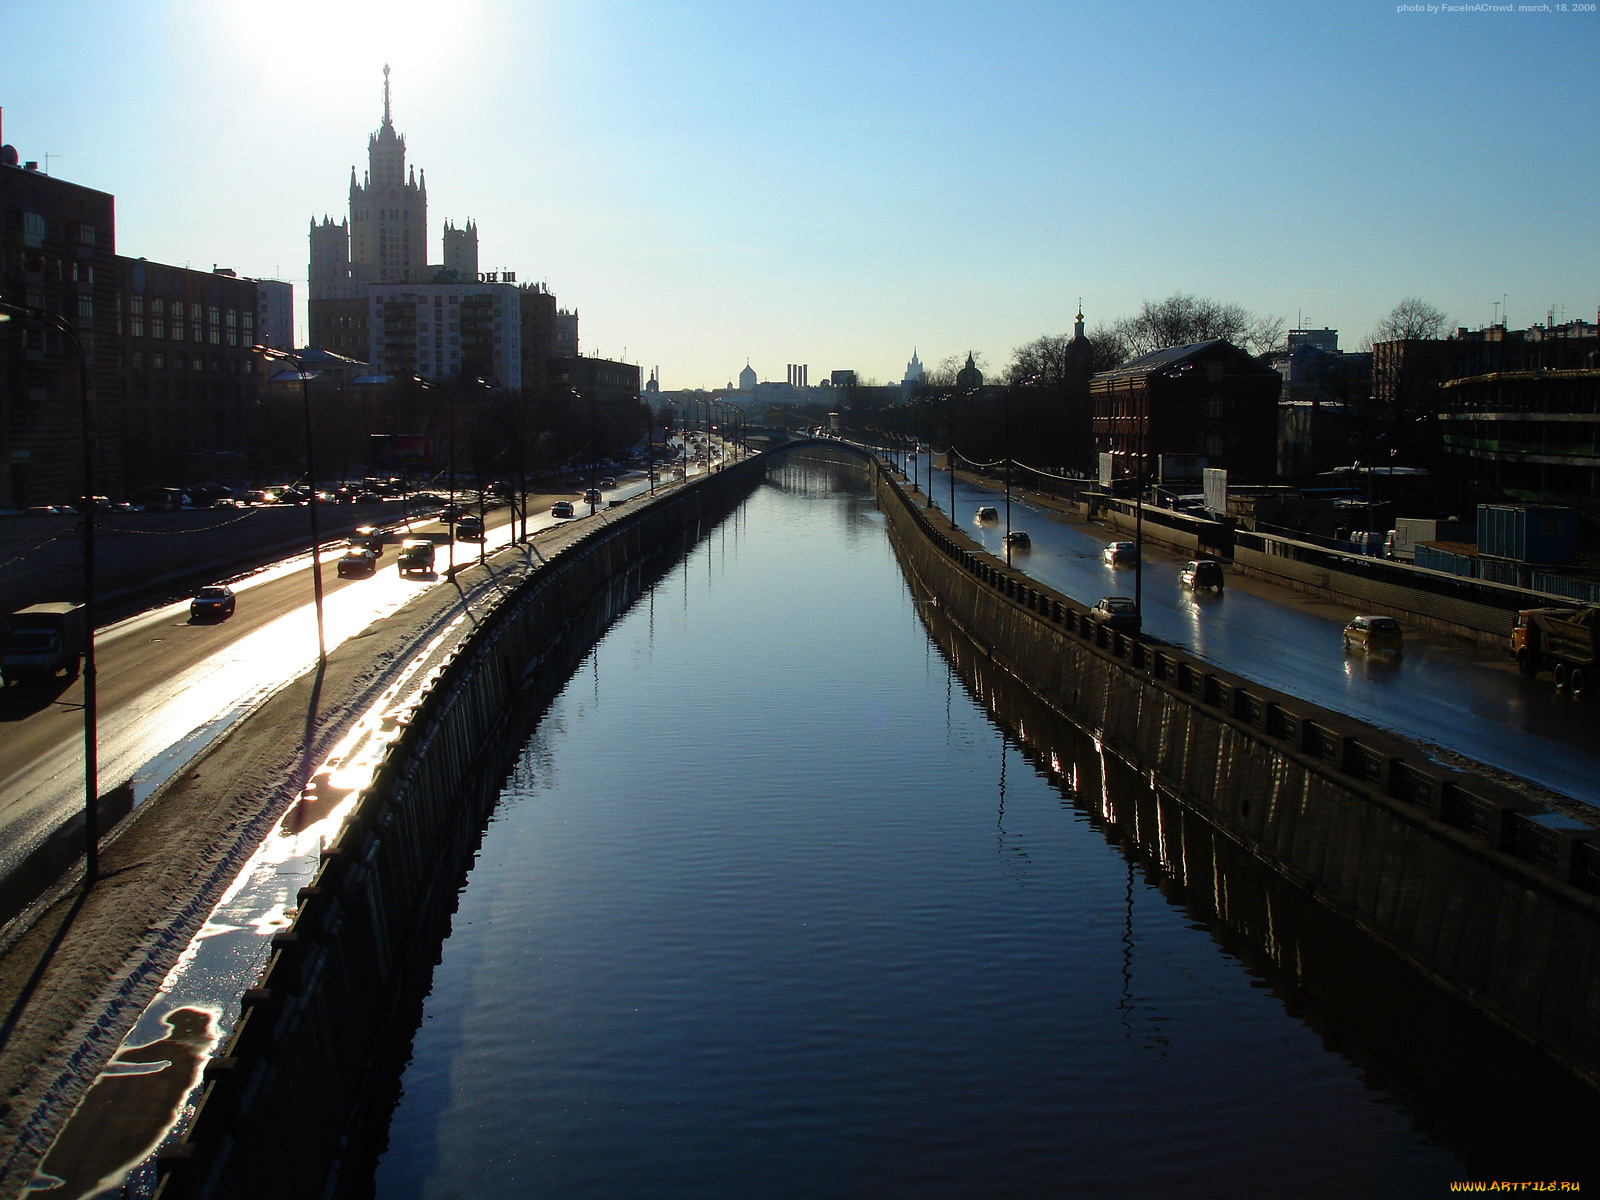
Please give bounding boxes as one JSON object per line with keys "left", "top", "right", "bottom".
{"left": 157, "top": 458, "right": 765, "bottom": 1200}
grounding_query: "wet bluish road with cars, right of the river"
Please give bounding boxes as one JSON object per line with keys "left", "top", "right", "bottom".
{"left": 918, "top": 470, "right": 1600, "bottom": 805}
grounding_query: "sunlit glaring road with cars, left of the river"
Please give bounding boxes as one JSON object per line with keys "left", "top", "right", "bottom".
{"left": 0, "top": 472, "right": 681, "bottom": 874}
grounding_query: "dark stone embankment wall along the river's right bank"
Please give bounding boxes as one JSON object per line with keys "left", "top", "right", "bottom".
{"left": 875, "top": 472, "right": 1600, "bottom": 1088}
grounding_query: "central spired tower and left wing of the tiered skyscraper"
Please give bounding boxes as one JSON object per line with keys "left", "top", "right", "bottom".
{"left": 310, "top": 66, "right": 428, "bottom": 301}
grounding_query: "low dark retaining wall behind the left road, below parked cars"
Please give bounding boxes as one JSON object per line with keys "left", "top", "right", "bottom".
{"left": 0, "top": 504, "right": 402, "bottom": 630}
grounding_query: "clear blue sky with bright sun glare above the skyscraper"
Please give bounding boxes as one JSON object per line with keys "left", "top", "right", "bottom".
{"left": 0, "top": 0, "right": 1600, "bottom": 389}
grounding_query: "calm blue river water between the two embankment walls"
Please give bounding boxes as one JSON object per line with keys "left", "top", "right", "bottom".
{"left": 374, "top": 462, "right": 1594, "bottom": 1200}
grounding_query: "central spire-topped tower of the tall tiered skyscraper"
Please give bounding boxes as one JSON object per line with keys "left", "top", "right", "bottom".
{"left": 350, "top": 64, "right": 428, "bottom": 283}
